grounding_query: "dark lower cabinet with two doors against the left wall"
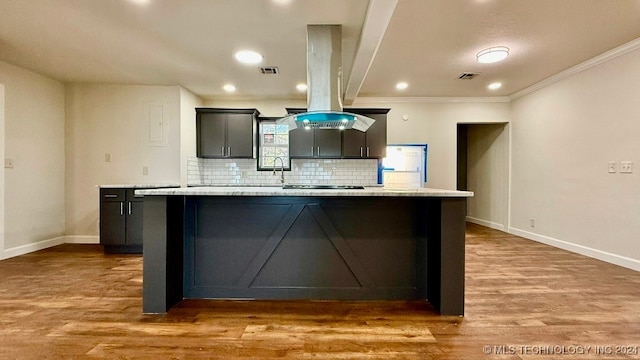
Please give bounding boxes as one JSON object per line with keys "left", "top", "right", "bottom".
{"left": 100, "top": 188, "right": 143, "bottom": 254}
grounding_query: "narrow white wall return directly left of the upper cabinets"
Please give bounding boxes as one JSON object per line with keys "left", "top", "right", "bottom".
{"left": 180, "top": 87, "right": 202, "bottom": 186}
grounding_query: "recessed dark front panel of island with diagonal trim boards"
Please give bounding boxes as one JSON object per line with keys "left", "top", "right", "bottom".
{"left": 184, "top": 197, "right": 419, "bottom": 299}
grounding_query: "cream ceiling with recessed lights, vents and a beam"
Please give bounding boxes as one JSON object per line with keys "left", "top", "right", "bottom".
{"left": 0, "top": 0, "right": 640, "bottom": 104}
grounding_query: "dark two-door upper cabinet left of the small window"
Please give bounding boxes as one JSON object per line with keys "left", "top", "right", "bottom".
{"left": 196, "top": 108, "right": 259, "bottom": 158}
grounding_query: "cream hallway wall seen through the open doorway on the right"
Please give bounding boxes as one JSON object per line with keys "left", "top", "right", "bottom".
{"left": 467, "top": 124, "right": 509, "bottom": 231}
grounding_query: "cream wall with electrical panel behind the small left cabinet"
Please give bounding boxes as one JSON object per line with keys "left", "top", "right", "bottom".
{"left": 66, "top": 84, "right": 181, "bottom": 238}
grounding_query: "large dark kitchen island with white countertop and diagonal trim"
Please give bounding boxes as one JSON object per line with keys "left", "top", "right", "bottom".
{"left": 136, "top": 187, "right": 473, "bottom": 315}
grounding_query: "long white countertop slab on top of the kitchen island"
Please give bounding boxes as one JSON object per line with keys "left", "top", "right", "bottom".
{"left": 136, "top": 186, "right": 473, "bottom": 197}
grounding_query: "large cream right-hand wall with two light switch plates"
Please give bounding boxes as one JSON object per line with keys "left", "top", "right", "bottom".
{"left": 509, "top": 45, "right": 640, "bottom": 270}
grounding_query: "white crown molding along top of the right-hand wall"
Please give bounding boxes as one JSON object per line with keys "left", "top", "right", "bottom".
{"left": 509, "top": 38, "right": 640, "bottom": 101}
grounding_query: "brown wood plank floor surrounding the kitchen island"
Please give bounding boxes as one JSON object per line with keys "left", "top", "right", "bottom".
{"left": 0, "top": 224, "right": 640, "bottom": 359}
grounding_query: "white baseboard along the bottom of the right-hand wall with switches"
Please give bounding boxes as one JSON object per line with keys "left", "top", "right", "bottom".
{"left": 508, "top": 227, "right": 640, "bottom": 271}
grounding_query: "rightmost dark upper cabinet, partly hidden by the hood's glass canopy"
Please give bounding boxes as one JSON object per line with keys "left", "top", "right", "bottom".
{"left": 342, "top": 109, "right": 389, "bottom": 158}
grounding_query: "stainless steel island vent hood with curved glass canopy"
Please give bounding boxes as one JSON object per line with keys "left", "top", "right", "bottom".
{"left": 277, "top": 25, "right": 375, "bottom": 132}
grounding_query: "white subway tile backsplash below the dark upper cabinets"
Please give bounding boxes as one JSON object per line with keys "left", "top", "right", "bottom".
{"left": 187, "top": 157, "right": 378, "bottom": 186}
